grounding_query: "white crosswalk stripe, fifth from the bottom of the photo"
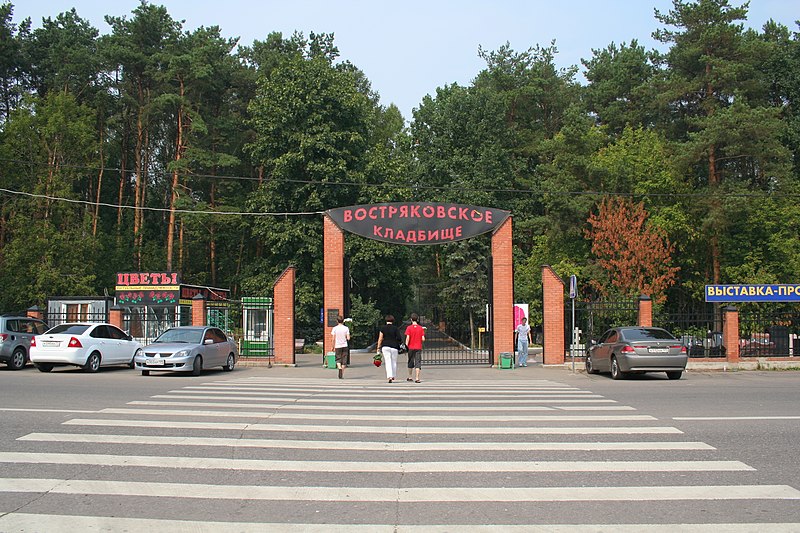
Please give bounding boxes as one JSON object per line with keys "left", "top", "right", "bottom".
{"left": 63, "top": 418, "right": 683, "bottom": 435}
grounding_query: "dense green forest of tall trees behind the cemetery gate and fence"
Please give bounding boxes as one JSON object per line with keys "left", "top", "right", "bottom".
{"left": 0, "top": 0, "right": 800, "bottom": 337}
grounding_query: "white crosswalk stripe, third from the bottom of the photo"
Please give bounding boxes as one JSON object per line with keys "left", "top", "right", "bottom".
{"left": 0, "top": 452, "right": 755, "bottom": 474}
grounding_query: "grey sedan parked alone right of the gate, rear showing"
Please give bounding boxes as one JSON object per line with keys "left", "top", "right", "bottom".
{"left": 586, "top": 326, "right": 688, "bottom": 379}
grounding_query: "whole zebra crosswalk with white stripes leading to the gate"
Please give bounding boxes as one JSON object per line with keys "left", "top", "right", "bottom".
{"left": 0, "top": 374, "right": 800, "bottom": 533}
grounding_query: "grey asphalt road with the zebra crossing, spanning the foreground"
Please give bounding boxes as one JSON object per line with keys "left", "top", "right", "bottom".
{"left": 0, "top": 354, "right": 800, "bottom": 533}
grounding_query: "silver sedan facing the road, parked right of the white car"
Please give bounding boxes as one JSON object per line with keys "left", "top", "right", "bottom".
{"left": 134, "top": 326, "right": 239, "bottom": 376}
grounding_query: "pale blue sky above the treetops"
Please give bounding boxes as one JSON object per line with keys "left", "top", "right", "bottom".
{"left": 10, "top": 0, "right": 800, "bottom": 120}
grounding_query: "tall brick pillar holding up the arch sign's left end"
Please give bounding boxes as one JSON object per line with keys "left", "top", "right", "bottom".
{"left": 322, "top": 215, "right": 344, "bottom": 353}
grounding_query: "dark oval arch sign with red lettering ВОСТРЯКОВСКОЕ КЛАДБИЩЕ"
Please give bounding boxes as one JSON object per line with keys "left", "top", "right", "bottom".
{"left": 326, "top": 202, "right": 511, "bottom": 245}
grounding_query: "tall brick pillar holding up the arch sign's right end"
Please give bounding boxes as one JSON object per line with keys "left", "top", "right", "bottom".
{"left": 492, "top": 217, "right": 514, "bottom": 365}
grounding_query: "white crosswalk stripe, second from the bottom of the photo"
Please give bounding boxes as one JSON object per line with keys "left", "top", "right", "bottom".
{"left": 0, "top": 478, "right": 800, "bottom": 503}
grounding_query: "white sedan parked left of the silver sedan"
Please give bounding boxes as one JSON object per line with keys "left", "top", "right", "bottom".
{"left": 29, "top": 323, "right": 142, "bottom": 372}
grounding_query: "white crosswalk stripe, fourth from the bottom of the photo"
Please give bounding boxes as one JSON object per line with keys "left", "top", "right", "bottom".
{"left": 17, "top": 433, "right": 716, "bottom": 452}
